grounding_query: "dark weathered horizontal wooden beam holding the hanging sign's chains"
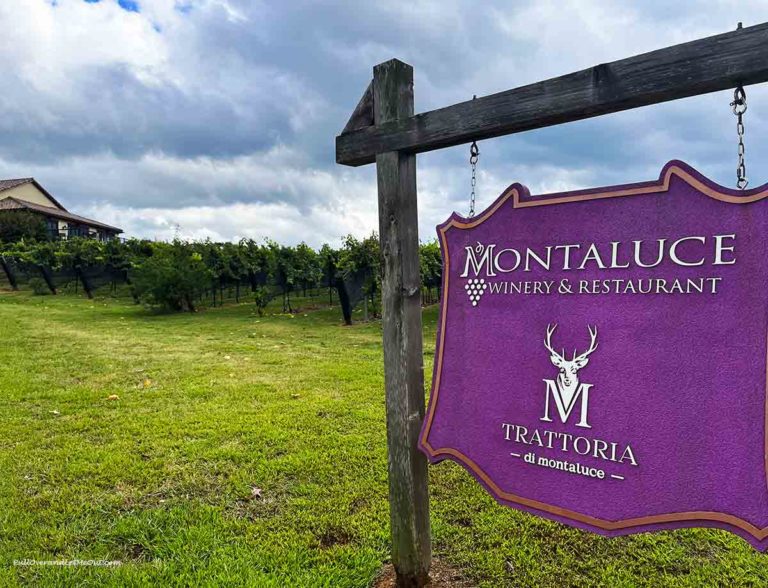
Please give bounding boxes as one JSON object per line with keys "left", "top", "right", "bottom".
{"left": 336, "top": 23, "right": 768, "bottom": 166}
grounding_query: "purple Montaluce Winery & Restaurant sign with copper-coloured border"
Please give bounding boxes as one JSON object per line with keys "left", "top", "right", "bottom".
{"left": 419, "top": 161, "right": 768, "bottom": 550}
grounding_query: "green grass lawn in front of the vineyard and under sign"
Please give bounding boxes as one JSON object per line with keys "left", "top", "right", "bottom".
{"left": 0, "top": 293, "right": 768, "bottom": 587}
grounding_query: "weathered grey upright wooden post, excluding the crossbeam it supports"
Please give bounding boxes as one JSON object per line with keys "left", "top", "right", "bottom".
{"left": 373, "top": 60, "right": 431, "bottom": 586}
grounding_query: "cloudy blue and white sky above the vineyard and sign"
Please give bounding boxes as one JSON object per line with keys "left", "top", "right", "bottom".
{"left": 0, "top": 0, "right": 768, "bottom": 245}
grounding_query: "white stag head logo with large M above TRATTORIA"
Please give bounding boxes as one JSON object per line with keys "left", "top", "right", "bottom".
{"left": 541, "top": 324, "right": 597, "bottom": 429}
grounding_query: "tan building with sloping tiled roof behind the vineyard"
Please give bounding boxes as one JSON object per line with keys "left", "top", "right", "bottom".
{"left": 0, "top": 178, "right": 123, "bottom": 241}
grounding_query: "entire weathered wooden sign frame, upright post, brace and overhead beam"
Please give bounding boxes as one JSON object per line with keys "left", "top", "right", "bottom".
{"left": 336, "top": 23, "right": 768, "bottom": 586}
